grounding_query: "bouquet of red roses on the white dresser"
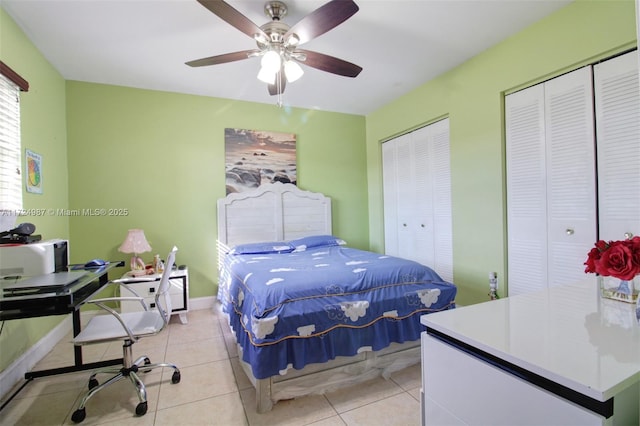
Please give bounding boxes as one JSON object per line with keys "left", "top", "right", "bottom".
{"left": 584, "top": 237, "right": 640, "bottom": 281}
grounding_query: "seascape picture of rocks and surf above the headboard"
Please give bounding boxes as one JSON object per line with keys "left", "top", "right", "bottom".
{"left": 224, "top": 128, "right": 298, "bottom": 195}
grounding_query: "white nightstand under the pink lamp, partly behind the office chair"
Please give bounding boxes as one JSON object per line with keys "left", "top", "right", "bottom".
{"left": 120, "top": 267, "right": 189, "bottom": 324}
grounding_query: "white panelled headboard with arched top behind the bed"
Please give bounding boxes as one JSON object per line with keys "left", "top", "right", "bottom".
{"left": 218, "top": 182, "right": 332, "bottom": 247}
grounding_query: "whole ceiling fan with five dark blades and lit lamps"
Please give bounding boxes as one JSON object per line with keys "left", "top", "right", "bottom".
{"left": 186, "top": 0, "right": 362, "bottom": 95}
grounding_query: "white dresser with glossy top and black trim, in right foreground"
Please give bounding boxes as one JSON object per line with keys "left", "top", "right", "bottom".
{"left": 421, "top": 284, "right": 640, "bottom": 426}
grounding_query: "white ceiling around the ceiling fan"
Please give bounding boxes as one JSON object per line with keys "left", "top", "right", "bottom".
{"left": 1, "top": 0, "right": 571, "bottom": 115}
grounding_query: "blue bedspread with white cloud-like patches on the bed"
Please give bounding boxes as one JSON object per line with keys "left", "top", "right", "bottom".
{"left": 218, "top": 246, "right": 456, "bottom": 379}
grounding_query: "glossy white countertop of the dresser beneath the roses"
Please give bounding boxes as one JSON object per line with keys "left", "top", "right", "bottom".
{"left": 421, "top": 282, "right": 640, "bottom": 401}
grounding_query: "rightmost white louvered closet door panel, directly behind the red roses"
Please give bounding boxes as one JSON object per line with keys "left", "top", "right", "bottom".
{"left": 594, "top": 51, "right": 640, "bottom": 241}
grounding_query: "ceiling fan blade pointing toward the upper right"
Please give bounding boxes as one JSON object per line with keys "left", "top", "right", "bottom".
{"left": 286, "top": 0, "right": 360, "bottom": 44}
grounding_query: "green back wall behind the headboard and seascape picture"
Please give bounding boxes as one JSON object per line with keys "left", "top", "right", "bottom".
{"left": 67, "top": 82, "right": 369, "bottom": 298}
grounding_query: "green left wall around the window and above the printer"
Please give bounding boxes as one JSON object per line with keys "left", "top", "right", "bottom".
{"left": 0, "top": 9, "right": 69, "bottom": 370}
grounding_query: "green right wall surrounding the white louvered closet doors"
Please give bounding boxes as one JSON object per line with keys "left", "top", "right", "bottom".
{"left": 367, "top": 0, "right": 636, "bottom": 304}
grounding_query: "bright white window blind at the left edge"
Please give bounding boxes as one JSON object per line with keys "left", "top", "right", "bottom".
{"left": 0, "top": 75, "right": 22, "bottom": 216}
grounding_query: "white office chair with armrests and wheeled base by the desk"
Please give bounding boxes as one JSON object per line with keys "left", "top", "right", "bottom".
{"left": 71, "top": 247, "right": 180, "bottom": 423}
